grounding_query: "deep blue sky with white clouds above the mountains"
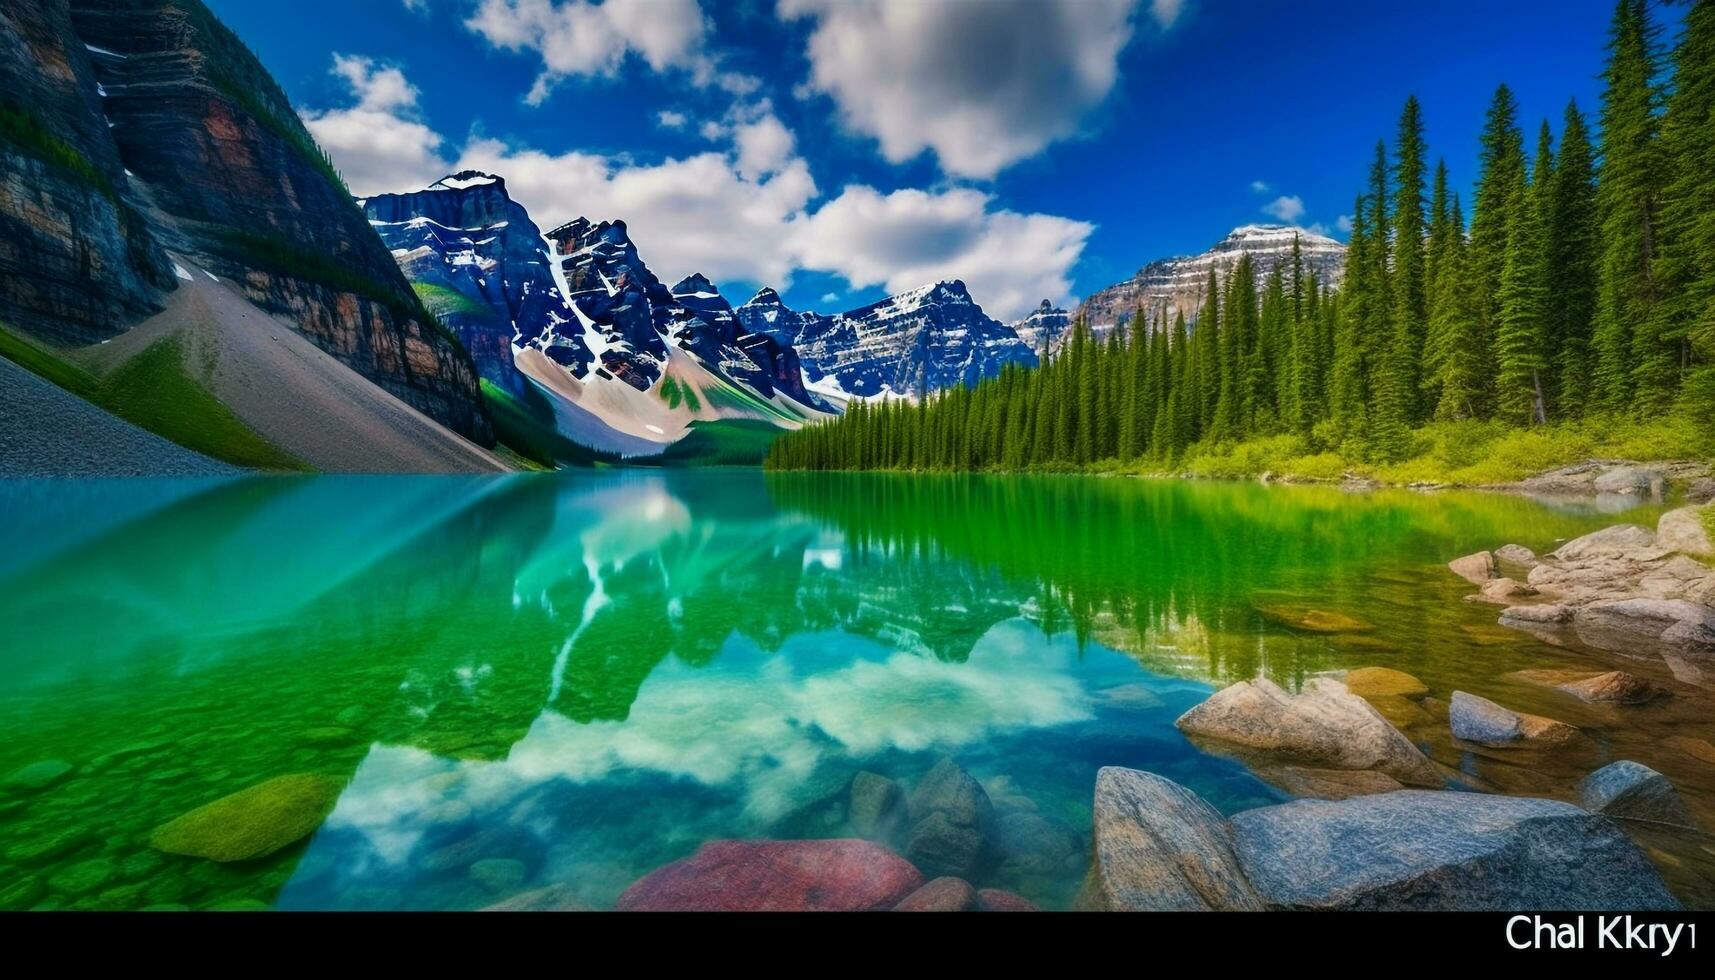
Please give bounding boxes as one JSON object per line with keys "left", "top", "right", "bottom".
{"left": 209, "top": 0, "right": 1677, "bottom": 319}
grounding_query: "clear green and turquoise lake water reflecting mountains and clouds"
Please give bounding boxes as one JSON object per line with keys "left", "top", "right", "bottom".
{"left": 0, "top": 472, "right": 1715, "bottom": 908}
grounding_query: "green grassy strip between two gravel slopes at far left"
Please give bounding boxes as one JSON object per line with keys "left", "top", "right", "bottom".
{"left": 0, "top": 330, "right": 310, "bottom": 472}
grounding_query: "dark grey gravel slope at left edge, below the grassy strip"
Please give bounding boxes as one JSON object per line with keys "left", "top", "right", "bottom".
{"left": 0, "top": 359, "right": 240, "bottom": 477}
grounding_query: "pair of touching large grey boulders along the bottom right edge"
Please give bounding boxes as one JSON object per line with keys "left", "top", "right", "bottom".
{"left": 1080, "top": 767, "right": 1679, "bottom": 911}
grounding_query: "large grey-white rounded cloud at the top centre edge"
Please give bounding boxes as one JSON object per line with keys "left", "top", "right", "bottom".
{"left": 779, "top": 0, "right": 1145, "bottom": 178}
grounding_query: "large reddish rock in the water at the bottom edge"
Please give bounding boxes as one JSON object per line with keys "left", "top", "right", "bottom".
{"left": 617, "top": 839, "right": 923, "bottom": 911}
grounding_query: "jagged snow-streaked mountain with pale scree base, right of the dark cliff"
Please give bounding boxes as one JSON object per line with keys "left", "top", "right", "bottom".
{"left": 358, "top": 172, "right": 835, "bottom": 455}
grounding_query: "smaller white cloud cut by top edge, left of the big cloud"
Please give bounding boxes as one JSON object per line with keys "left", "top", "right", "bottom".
{"left": 465, "top": 0, "right": 710, "bottom": 105}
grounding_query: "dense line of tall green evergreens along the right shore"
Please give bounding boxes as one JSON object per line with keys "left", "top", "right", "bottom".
{"left": 768, "top": 0, "right": 1715, "bottom": 470}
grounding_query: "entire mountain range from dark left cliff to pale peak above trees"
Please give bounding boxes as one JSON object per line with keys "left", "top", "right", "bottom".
{"left": 0, "top": 0, "right": 1345, "bottom": 472}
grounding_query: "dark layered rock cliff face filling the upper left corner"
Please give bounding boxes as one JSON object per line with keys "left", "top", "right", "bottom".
{"left": 0, "top": 0, "right": 494, "bottom": 445}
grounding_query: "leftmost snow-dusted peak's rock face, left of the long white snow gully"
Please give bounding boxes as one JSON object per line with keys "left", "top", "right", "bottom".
{"left": 358, "top": 172, "right": 562, "bottom": 395}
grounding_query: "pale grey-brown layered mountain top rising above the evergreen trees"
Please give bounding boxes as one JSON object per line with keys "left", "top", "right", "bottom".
{"left": 1079, "top": 225, "right": 1346, "bottom": 336}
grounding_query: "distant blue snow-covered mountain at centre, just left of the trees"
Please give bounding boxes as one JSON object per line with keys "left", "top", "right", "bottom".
{"left": 736, "top": 280, "right": 1036, "bottom": 398}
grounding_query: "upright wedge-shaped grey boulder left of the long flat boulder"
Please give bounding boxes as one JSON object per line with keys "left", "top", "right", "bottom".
{"left": 1079, "top": 765, "right": 1262, "bottom": 911}
